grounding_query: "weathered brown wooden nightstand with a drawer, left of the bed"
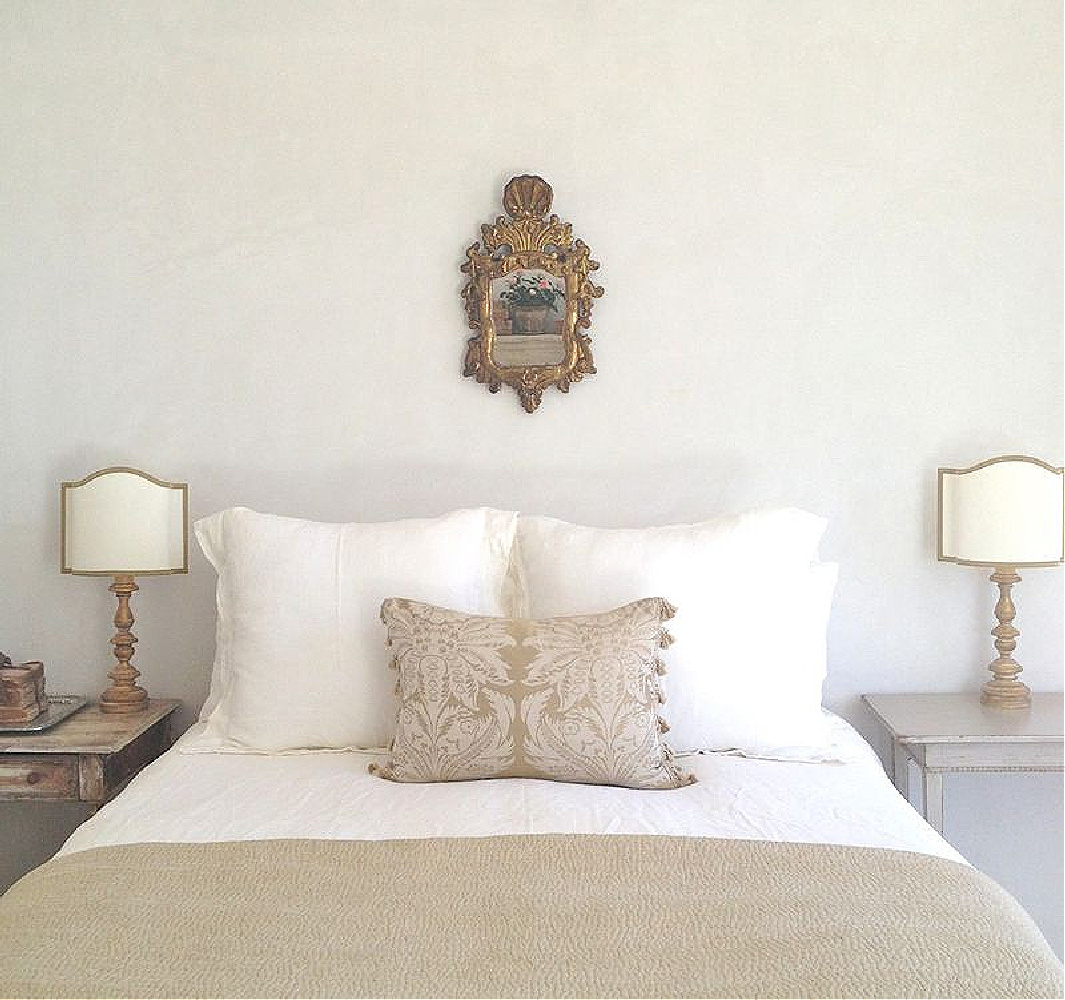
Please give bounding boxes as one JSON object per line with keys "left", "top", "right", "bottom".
{"left": 0, "top": 700, "right": 181, "bottom": 808}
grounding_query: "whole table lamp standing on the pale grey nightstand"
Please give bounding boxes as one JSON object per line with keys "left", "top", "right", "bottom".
{"left": 937, "top": 455, "right": 1065, "bottom": 708}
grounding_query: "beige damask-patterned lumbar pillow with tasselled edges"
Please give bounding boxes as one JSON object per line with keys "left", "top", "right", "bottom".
{"left": 371, "top": 597, "right": 694, "bottom": 788}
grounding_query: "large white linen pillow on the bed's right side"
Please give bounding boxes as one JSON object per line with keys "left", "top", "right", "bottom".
{"left": 514, "top": 508, "right": 837, "bottom": 756}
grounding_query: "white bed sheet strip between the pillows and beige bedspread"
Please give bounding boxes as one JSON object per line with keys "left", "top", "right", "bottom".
{"left": 60, "top": 716, "right": 963, "bottom": 860}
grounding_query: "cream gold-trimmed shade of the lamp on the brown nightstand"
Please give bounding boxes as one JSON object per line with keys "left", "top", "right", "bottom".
{"left": 60, "top": 468, "right": 189, "bottom": 576}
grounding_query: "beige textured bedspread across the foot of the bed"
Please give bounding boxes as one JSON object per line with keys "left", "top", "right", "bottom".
{"left": 0, "top": 836, "right": 1063, "bottom": 997}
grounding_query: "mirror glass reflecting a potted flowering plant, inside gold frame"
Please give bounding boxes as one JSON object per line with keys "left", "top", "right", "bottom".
{"left": 491, "top": 268, "right": 566, "bottom": 368}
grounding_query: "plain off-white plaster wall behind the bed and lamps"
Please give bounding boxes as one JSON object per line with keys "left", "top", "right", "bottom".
{"left": 0, "top": 0, "right": 1063, "bottom": 951}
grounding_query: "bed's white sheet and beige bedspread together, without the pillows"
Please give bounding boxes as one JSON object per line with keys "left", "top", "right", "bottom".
{"left": 0, "top": 717, "right": 1062, "bottom": 997}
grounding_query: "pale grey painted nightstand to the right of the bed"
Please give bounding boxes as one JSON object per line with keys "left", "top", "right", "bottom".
{"left": 862, "top": 691, "right": 1065, "bottom": 833}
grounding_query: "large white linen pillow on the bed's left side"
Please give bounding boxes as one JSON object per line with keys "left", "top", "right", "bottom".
{"left": 185, "top": 507, "right": 517, "bottom": 753}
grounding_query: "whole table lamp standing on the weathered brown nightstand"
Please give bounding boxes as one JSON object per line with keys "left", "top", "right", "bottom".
{"left": 60, "top": 468, "right": 189, "bottom": 712}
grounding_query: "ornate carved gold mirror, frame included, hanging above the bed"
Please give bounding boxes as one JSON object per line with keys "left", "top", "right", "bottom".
{"left": 462, "top": 175, "right": 603, "bottom": 413}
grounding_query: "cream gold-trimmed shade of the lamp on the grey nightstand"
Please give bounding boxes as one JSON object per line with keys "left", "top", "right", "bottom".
{"left": 938, "top": 455, "right": 1065, "bottom": 567}
